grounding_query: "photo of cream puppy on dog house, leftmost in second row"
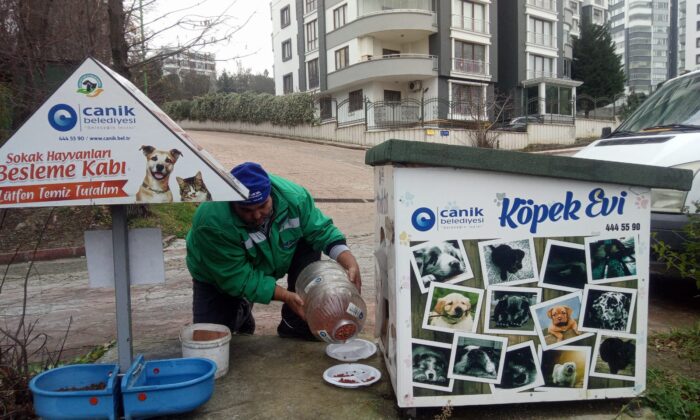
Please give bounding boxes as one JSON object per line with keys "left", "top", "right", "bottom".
{"left": 423, "top": 283, "right": 484, "bottom": 333}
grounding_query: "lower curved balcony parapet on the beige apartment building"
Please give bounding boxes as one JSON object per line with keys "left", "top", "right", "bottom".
{"left": 328, "top": 54, "right": 438, "bottom": 90}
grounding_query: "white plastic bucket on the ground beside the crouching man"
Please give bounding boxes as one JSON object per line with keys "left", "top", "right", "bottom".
{"left": 180, "top": 324, "right": 231, "bottom": 378}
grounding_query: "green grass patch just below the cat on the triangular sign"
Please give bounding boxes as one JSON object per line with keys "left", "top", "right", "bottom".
{"left": 129, "top": 203, "right": 197, "bottom": 239}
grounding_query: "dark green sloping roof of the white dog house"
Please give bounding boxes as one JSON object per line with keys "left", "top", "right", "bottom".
{"left": 365, "top": 139, "right": 693, "bottom": 191}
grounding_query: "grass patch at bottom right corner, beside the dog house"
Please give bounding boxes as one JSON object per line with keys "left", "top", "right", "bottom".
{"left": 644, "top": 369, "right": 700, "bottom": 419}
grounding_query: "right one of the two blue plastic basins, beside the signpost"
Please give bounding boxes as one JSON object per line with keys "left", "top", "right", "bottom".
{"left": 121, "top": 355, "right": 216, "bottom": 419}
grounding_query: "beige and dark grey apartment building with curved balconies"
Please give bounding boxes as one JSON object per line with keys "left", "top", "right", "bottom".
{"left": 270, "top": 0, "right": 580, "bottom": 121}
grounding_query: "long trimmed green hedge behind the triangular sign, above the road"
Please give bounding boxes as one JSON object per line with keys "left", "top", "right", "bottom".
{"left": 163, "top": 92, "right": 314, "bottom": 126}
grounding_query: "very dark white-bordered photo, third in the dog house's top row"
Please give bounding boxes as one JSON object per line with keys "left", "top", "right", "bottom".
{"left": 537, "top": 240, "right": 587, "bottom": 292}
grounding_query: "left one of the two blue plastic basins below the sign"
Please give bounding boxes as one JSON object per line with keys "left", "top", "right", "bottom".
{"left": 29, "top": 364, "right": 119, "bottom": 419}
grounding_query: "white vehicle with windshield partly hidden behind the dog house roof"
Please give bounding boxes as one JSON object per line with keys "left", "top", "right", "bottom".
{"left": 574, "top": 70, "right": 700, "bottom": 272}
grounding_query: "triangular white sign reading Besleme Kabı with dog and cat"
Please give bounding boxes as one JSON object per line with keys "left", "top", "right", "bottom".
{"left": 0, "top": 58, "right": 248, "bottom": 207}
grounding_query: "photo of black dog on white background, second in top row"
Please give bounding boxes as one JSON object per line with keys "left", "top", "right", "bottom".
{"left": 479, "top": 238, "right": 539, "bottom": 287}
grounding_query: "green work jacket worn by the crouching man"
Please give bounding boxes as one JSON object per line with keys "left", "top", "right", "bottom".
{"left": 187, "top": 175, "right": 345, "bottom": 303}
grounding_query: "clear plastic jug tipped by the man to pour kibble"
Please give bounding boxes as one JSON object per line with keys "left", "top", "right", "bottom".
{"left": 296, "top": 260, "right": 367, "bottom": 343}
